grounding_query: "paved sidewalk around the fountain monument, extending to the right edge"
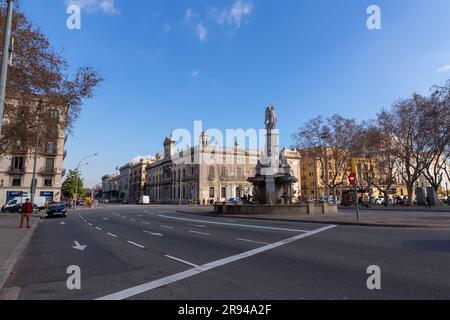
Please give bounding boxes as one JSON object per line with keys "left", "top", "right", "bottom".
{"left": 179, "top": 208, "right": 450, "bottom": 229}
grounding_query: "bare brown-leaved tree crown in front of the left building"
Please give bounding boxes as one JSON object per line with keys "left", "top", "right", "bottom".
{"left": 0, "top": 2, "right": 103, "bottom": 154}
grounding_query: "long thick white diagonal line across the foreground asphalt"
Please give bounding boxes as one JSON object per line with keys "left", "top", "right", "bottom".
{"left": 96, "top": 225, "right": 337, "bottom": 300}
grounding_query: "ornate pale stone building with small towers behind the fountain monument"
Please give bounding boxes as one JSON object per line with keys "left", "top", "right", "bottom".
{"left": 146, "top": 133, "right": 301, "bottom": 205}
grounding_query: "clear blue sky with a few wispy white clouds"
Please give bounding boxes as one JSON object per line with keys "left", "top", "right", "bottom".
{"left": 22, "top": 0, "right": 450, "bottom": 185}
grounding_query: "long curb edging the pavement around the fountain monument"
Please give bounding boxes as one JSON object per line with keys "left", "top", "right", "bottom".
{"left": 176, "top": 210, "right": 450, "bottom": 229}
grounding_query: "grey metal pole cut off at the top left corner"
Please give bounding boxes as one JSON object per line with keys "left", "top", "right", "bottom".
{"left": 0, "top": 0, "right": 14, "bottom": 135}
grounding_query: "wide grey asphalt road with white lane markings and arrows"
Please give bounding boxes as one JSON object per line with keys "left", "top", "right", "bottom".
{"left": 6, "top": 206, "right": 450, "bottom": 300}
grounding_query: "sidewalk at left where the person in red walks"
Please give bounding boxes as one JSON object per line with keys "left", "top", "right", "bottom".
{"left": 0, "top": 213, "right": 40, "bottom": 291}
